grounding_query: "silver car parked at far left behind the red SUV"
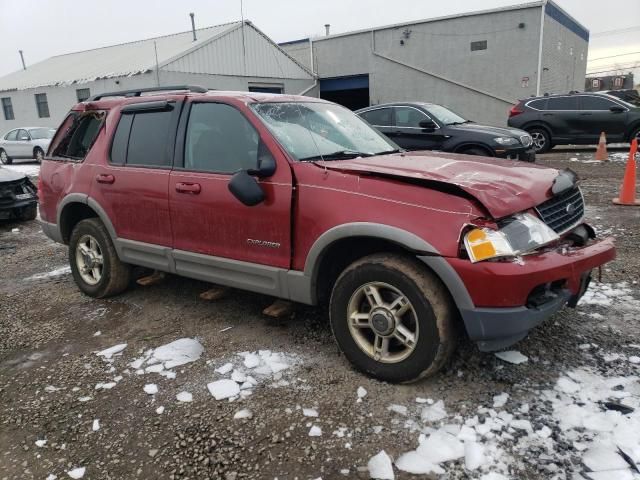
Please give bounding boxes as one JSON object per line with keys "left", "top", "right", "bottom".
{"left": 0, "top": 127, "right": 56, "bottom": 165}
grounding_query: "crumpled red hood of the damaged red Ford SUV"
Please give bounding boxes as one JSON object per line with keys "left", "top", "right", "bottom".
{"left": 317, "top": 152, "right": 559, "bottom": 219}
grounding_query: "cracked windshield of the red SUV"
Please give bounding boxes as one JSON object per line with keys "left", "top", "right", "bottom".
{"left": 251, "top": 102, "right": 398, "bottom": 160}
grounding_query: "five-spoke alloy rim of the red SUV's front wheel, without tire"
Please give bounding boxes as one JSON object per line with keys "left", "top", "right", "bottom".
{"left": 347, "top": 282, "right": 419, "bottom": 363}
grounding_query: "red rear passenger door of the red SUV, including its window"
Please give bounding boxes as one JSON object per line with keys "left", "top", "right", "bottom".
{"left": 91, "top": 101, "right": 182, "bottom": 258}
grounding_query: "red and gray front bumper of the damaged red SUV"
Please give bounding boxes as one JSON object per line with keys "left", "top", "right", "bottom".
{"left": 447, "top": 239, "right": 615, "bottom": 351}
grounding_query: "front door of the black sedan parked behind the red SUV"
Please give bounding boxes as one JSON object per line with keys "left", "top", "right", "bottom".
{"left": 393, "top": 106, "right": 444, "bottom": 150}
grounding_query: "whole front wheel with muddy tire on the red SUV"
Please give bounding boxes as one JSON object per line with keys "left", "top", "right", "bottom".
{"left": 330, "top": 254, "right": 457, "bottom": 383}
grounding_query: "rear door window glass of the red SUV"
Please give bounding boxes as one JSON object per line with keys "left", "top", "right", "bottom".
{"left": 111, "top": 110, "right": 174, "bottom": 168}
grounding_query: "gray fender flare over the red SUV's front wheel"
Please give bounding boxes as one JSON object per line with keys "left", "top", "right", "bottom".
{"left": 304, "top": 222, "right": 473, "bottom": 309}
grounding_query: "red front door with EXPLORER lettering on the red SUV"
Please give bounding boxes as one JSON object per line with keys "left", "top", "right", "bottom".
{"left": 169, "top": 101, "right": 292, "bottom": 272}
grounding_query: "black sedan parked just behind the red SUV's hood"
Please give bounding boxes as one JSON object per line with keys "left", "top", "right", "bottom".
{"left": 356, "top": 103, "right": 535, "bottom": 162}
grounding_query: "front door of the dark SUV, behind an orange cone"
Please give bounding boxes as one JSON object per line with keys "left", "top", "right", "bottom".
{"left": 579, "top": 95, "right": 628, "bottom": 143}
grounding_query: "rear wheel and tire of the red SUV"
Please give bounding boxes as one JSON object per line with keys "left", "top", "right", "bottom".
{"left": 69, "top": 218, "right": 131, "bottom": 298}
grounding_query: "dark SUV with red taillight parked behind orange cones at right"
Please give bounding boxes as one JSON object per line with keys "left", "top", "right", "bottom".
{"left": 509, "top": 93, "right": 640, "bottom": 153}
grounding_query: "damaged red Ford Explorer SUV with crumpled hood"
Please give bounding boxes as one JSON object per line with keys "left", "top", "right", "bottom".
{"left": 40, "top": 87, "right": 615, "bottom": 382}
